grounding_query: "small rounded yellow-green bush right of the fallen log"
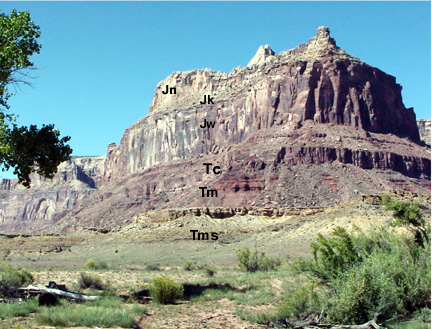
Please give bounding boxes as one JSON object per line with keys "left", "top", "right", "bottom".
{"left": 150, "top": 276, "right": 184, "bottom": 304}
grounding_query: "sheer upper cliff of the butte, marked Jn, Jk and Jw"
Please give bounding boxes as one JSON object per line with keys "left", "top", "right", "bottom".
{"left": 104, "top": 28, "right": 419, "bottom": 180}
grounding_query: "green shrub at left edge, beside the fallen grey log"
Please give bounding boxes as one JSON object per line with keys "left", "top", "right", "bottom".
{"left": 0, "top": 263, "right": 33, "bottom": 296}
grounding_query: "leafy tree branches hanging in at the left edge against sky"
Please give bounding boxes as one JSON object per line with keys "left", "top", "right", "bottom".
{"left": 0, "top": 10, "right": 72, "bottom": 187}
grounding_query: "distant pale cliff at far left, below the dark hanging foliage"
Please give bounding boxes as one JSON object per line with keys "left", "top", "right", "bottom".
{"left": 0, "top": 156, "right": 105, "bottom": 229}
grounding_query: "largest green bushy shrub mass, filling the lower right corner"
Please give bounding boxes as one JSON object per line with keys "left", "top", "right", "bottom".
{"left": 288, "top": 220, "right": 431, "bottom": 323}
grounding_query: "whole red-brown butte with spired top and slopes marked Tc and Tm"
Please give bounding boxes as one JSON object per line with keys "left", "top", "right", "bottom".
{"left": 3, "top": 27, "right": 430, "bottom": 229}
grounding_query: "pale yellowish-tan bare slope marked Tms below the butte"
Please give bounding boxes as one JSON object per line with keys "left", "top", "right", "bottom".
{"left": 0, "top": 195, "right": 416, "bottom": 270}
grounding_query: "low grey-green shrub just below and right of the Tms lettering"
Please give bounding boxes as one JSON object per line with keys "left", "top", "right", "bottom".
{"left": 236, "top": 248, "right": 281, "bottom": 272}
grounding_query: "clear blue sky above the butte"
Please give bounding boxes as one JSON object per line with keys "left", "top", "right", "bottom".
{"left": 0, "top": 2, "right": 431, "bottom": 178}
